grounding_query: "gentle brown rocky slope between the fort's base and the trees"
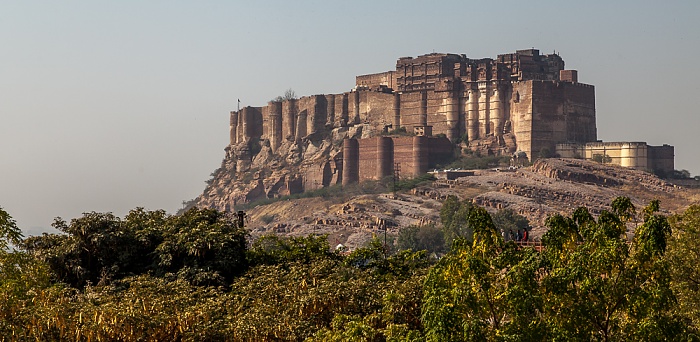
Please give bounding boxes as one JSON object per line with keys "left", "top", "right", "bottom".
{"left": 191, "top": 156, "right": 700, "bottom": 248}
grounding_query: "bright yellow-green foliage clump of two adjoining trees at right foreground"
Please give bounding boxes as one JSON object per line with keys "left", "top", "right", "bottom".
{"left": 423, "top": 198, "right": 692, "bottom": 341}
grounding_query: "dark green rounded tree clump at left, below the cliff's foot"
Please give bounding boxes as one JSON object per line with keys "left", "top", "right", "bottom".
{"left": 22, "top": 208, "right": 246, "bottom": 288}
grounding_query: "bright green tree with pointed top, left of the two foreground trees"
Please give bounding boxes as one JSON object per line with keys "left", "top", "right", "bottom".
{"left": 422, "top": 207, "right": 544, "bottom": 341}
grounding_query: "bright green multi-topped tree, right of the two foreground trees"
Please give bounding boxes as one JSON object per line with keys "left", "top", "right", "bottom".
{"left": 541, "top": 198, "right": 687, "bottom": 341}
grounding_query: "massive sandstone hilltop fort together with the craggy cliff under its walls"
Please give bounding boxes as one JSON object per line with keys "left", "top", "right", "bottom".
{"left": 197, "top": 49, "right": 673, "bottom": 209}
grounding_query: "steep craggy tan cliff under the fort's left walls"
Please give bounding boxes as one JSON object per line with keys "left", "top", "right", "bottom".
{"left": 189, "top": 124, "right": 377, "bottom": 211}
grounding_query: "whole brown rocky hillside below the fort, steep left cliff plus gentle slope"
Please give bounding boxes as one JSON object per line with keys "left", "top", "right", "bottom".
{"left": 190, "top": 118, "right": 700, "bottom": 248}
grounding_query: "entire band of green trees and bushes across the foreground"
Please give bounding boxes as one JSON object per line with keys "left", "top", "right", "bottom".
{"left": 0, "top": 198, "right": 700, "bottom": 341}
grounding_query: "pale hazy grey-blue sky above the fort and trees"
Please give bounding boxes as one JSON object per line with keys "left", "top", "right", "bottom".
{"left": 0, "top": 0, "right": 700, "bottom": 234}
